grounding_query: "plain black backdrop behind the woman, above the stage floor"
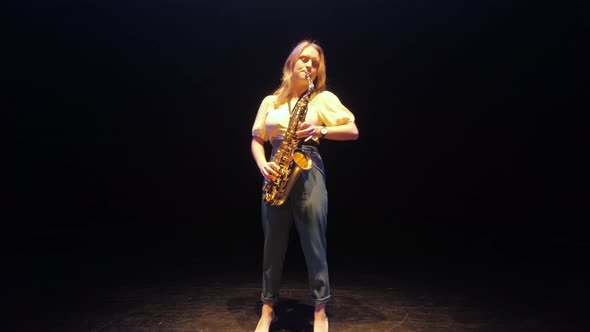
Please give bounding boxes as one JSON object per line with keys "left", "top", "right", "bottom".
{"left": 2, "top": 0, "right": 589, "bottom": 278}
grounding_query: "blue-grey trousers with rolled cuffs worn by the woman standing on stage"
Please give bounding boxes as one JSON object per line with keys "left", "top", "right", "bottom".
{"left": 261, "top": 146, "right": 330, "bottom": 304}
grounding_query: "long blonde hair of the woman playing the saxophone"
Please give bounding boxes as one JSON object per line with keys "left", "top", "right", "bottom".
{"left": 273, "top": 39, "right": 326, "bottom": 107}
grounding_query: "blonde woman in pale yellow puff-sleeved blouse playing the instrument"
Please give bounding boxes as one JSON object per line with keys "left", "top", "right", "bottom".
{"left": 251, "top": 40, "right": 359, "bottom": 332}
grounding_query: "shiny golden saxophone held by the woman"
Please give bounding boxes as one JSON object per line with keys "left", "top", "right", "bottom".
{"left": 262, "top": 73, "right": 314, "bottom": 206}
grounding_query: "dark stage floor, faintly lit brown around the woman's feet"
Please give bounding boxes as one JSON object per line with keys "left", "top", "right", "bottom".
{"left": 2, "top": 228, "right": 589, "bottom": 332}
